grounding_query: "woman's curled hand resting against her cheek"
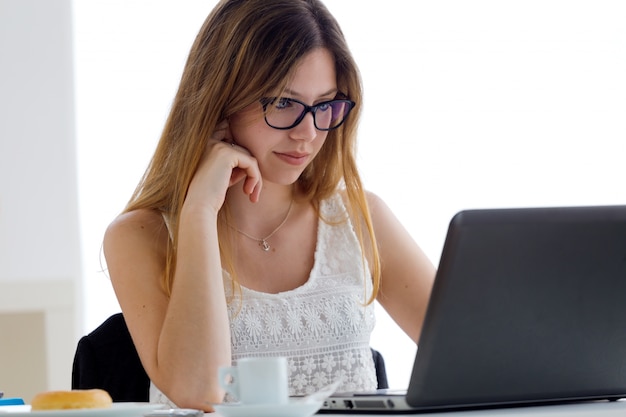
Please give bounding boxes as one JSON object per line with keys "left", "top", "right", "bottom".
{"left": 185, "top": 120, "right": 263, "bottom": 213}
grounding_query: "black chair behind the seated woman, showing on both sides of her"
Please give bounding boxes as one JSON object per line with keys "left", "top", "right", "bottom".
{"left": 72, "top": 313, "right": 389, "bottom": 402}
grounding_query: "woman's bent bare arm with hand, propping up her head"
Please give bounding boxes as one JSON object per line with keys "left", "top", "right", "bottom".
{"left": 104, "top": 130, "right": 261, "bottom": 410}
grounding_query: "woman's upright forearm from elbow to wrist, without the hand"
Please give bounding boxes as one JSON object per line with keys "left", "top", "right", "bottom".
{"left": 155, "top": 207, "right": 231, "bottom": 409}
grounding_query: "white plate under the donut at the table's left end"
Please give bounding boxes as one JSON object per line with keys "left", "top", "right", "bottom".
{"left": 0, "top": 403, "right": 163, "bottom": 417}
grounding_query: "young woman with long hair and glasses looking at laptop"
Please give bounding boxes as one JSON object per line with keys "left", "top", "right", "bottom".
{"left": 104, "top": 0, "right": 434, "bottom": 410}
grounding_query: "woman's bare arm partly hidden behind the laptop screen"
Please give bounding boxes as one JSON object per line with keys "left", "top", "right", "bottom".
{"left": 368, "top": 193, "right": 435, "bottom": 343}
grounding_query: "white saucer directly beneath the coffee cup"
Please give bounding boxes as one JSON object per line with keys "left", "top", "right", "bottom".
{"left": 213, "top": 399, "right": 323, "bottom": 417}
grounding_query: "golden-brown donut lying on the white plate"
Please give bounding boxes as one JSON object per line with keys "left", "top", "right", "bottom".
{"left": 31, "top": 389, "right": 113, "bottom": 411}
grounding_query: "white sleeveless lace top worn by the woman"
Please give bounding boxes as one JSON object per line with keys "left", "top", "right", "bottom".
{"left": 150, "top": 195, "right": 377, "bottom": 405}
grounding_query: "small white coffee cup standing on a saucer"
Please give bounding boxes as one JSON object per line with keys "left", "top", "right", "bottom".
{"left": 218, "top": 357, "right": 289, "bottom": 405}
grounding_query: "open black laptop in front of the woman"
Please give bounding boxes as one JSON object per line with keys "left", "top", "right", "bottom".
{"left": 322, "top": 206, "right": 626, "bottom": 414}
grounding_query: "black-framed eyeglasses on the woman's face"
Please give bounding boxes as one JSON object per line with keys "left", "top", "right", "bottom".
{"left": 261, "top": 97, "right": 355, "bottom": 131}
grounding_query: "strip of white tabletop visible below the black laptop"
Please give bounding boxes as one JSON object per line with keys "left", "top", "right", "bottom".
{"left": 320, "top": 401, "right": 626, "bottom": 417}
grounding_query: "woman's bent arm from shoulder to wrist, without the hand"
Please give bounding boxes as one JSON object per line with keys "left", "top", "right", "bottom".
{"left": 104, "top": 206, "right": 231, "bottom": 410}
